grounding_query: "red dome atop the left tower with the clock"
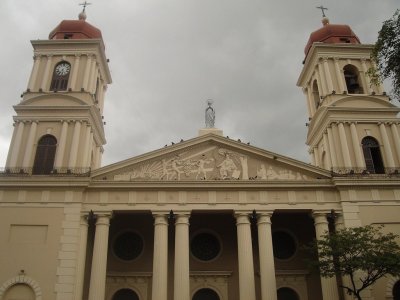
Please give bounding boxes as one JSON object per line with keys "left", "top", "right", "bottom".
{"left": 49, "top": 19, "right": 102, "bottom": 40}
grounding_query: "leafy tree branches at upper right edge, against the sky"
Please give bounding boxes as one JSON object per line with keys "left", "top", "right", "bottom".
{"left": 369, "top": 10, "right": 400, "bottom": 100}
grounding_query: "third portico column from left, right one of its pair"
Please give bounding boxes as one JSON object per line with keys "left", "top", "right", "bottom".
{"left": 174, "top": 213, "right": 190, "bottom": 300}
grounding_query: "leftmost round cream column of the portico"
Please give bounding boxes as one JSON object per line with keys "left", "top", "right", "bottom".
{"left": 89, "top": 214, "right": 111, "bottom": 300}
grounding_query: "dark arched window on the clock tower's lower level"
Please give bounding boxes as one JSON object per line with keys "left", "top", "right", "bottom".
{"left": 32, "top": 134, "right": 57, "bottom": 175}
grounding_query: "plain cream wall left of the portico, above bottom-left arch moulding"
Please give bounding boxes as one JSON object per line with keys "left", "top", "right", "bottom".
{"left": 0, "top": 205, "right": 63, "bottom": 299}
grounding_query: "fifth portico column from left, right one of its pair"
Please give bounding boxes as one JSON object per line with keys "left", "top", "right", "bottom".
{"left": 257, "top": 212, "right": 277, "bottom": 300}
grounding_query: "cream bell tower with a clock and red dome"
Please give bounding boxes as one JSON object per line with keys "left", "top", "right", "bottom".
{"left": 6, "top": 11, "right": 111, "bottom": 175}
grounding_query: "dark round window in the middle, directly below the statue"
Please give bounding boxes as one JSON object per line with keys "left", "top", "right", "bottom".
{"left": 190, "top": 232, "right": 221, "bottom": 261}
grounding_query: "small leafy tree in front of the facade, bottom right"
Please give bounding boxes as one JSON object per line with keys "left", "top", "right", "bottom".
{"left": 310, "top": 226, "right": 400, "bottom": 300}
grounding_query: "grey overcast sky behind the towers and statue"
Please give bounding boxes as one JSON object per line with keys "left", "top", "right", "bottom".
{"left": 0, "top": 0, "right": 400, "bottom": 166}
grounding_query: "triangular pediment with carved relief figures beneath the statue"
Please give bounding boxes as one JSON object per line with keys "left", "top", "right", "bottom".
{"left": 92, "top": 134, "right": 330, "bottom": 182}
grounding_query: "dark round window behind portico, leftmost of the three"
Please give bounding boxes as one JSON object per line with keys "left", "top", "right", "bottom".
{"left": 113, "top": 231, "right": 143, "bottom": 260}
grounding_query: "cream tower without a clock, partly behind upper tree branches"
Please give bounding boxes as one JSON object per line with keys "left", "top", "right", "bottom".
{"left": 297, "top": 17, "right": 400, "bottom": 174}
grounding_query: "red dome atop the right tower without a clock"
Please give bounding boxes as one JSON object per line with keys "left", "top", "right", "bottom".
{"left": 304, "top": 19, "right": 360, "bottom": 56}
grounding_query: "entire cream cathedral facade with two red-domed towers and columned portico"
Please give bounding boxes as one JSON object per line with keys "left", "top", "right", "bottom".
{"left": 0, "top": 9, "right": 400, "bottom": 300}
